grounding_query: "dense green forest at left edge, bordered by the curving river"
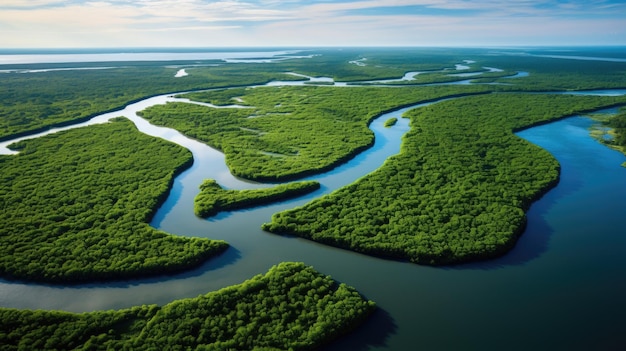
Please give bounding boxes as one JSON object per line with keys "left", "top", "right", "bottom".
{"left": 0, "top": 119, "right": 227, "bottom": 283}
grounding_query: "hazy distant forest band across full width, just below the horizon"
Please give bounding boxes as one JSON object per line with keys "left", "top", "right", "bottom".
{"left": 0, "top": 48, "right": 626, "bottom": 140}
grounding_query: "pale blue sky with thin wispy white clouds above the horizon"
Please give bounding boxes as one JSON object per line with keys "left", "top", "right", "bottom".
{"left": 0, "top": 0, "right": 626, "bottom": 49}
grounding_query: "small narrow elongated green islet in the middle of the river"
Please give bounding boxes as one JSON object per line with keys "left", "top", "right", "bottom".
{"left": 194, "top": 179, "right": 320, "bottom": 218}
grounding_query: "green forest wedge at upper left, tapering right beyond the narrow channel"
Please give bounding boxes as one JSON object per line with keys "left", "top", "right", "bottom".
{"left": 0, "top": 63, "right": 296, "bottom": 140}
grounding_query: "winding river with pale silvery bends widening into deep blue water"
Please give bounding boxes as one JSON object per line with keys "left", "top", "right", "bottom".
{"left": 0, "top": 67, "right": 626, "bottom": 350}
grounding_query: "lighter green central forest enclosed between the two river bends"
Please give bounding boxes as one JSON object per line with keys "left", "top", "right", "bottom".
{"left": 142, "top": 86, "right": 488, "bottom": 181}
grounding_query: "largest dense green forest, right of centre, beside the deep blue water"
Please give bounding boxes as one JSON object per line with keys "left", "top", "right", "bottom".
{"left": 263, "top": 94, "right": 626, "bottom": 264}
